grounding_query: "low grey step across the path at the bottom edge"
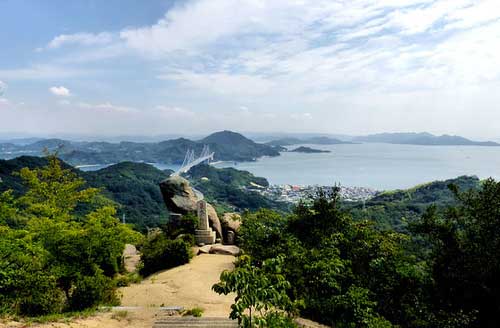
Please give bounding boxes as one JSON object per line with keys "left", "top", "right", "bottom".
{"left": 153, "top": 316, "right": 238, "bottom": 328}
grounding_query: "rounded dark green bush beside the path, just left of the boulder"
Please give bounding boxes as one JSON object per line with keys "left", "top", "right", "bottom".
{"left": 141, "top": 234, "right": 192, "bottom": 276}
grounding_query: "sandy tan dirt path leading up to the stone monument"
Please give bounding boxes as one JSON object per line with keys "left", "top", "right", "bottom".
{"left": 0, "top": 254, "right": 235, "bottom": 328}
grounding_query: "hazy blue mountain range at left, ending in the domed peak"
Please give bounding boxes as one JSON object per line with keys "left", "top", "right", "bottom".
{"left": 0, "top": 131, "right": 279, "bottom": 165}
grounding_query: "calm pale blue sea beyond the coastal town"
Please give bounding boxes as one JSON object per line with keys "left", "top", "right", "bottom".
{"left": 76, "top": 143, "right": 500, "bottom": 190}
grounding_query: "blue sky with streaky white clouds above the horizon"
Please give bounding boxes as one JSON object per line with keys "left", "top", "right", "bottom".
{"left": 0, "top": 0, "right": 500, "bottom": 139}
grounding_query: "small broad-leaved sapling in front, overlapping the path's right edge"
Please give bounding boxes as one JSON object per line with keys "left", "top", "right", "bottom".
{"left": 212, "top": 256, "right": 295, "bottom": 327}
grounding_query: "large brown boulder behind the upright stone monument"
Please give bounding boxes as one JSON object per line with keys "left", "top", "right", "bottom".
{"left": 160, "top": 175, "right": 222, "bottom": 238}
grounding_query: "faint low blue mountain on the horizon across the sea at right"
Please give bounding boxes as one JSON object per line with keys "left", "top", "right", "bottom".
{"left": 354, "top": 132, "right": 500, "bottom": 146}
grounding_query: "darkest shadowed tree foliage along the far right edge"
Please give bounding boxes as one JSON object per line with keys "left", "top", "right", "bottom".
{"left": 414, "top": 179, "right": 500, "bottom": 327}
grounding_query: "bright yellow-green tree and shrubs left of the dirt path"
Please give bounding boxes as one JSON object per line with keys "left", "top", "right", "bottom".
{"left": 0, "top": 156, "right": 141, "bottom": 315}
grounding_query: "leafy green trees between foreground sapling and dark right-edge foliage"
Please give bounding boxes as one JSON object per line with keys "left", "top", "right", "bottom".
{"left": 236, "top": 190, "right": 428, "bottom": 327}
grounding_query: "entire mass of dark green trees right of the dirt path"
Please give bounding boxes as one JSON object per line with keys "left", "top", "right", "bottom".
{"left": 226, "top": 179, "right": 500, "bottom": 328}
